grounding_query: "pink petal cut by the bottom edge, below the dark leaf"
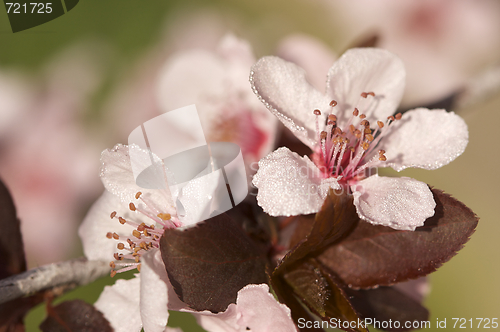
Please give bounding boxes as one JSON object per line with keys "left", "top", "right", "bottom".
{"left": 194, "top": 284, "right": 297, "bottom": 332}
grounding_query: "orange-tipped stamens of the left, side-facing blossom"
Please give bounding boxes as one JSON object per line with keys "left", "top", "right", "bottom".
{"left": 106, "top": 192, "right": 181, "bottom": 277}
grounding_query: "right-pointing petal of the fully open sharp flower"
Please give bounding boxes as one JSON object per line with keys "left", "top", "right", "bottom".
{"left": 377, "top": 108, "right": 469, "bottom": 171}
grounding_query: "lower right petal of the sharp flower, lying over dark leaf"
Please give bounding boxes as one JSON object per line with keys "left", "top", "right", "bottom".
{"left": 351, "top": 175, "right": 436, "bottom": 230}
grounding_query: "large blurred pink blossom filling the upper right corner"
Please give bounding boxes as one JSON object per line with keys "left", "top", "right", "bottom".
{"left": 325, "top": 0, "right": 500, "bottom": 105}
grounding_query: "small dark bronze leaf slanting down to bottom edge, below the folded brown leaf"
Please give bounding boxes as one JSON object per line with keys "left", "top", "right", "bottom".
{"left": 283, "top": 259, "right": 368, "bottom": 331}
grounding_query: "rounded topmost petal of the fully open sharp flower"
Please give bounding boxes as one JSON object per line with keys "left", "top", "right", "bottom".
{"left": 326, "top": 48, "right": 406, "bottom": 126}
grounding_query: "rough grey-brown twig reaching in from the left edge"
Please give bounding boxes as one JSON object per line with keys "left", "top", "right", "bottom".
{"left": 0, "top": 258, "right": 110, "bottom": 304}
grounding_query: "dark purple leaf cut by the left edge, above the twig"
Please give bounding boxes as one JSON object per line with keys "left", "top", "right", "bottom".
{"left": 0, "top": 180, "right": 26, "bottom": 279}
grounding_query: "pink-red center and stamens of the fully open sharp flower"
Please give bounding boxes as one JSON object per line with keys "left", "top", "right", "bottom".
{"left": 312, "top": 92, "right": 401, "bottom": 184}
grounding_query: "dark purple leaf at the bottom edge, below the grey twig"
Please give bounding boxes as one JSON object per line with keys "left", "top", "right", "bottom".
{"left": 40, "top": 300, "right": 113, "bottom": 332}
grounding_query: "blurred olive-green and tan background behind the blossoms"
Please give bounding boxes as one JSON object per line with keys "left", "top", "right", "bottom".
{"left": 0, "top": 0, "right": 500, "bottom": 331}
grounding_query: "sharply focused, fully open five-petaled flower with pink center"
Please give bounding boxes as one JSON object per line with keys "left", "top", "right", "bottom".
{"left": 250, "top": 48, "right": 468, "bottom": 230}
